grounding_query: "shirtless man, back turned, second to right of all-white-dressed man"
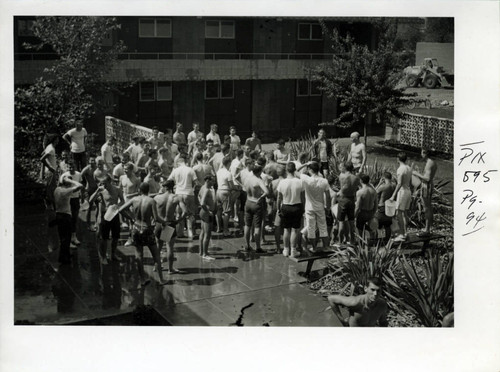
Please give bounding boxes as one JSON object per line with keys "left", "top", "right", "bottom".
{"left": 354, "top": 173, "right": 378, "bottom": 236}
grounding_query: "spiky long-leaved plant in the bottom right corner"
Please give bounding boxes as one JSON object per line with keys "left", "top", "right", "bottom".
{"left": 384, "top": 252, "right": 454, "bottom": 327}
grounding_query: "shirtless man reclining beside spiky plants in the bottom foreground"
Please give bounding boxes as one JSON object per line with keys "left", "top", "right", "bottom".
{"left": 328, "top": 278, "right": 389, "bottom": 327}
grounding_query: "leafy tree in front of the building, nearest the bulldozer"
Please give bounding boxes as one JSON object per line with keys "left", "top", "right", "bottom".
{"left": 311, "top": 20, "right": 408, "bottom": 144}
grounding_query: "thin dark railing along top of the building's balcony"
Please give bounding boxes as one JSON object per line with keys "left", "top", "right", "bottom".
{"left": 14, "top": 52, "right": 334, "bottom": 61}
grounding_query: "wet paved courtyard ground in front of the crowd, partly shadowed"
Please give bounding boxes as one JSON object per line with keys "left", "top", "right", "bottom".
{"left": 14, "top": 205, "right": 340, "bottom": 326}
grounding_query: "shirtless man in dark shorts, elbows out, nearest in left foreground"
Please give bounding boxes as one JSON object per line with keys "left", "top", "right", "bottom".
{"left": 119, "top": 182, "right": 166, "bottom": 287}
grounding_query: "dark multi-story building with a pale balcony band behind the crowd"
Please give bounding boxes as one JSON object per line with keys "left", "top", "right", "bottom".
{"left": 14, "top": 16, "right": 379, "bottom": 139}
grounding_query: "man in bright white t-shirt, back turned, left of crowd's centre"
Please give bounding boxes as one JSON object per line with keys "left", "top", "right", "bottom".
{"left": 168, "top": 154, "right": 198, "bottom": 239}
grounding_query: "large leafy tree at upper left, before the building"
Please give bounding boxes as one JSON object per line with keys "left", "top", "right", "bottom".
{"left": 15, "top": 17, "right": 125, "bottom": 152}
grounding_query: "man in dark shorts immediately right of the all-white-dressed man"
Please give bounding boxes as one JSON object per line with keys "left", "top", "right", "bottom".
{"left": 338, "top": 161, "right": 360, "bottom": 244}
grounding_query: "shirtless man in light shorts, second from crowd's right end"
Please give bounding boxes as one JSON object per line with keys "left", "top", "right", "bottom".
{"left": 391, "top": 152, "right": 412, "bottom": 242}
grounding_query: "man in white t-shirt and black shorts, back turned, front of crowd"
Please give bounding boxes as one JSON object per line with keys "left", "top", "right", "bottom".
{"left": 277, "top": 162, "right": 304, "bottom": 257}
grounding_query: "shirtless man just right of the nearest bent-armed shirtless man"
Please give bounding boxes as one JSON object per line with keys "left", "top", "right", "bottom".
{"left": 154, "top": 180, "right": 183, "bottom": 274}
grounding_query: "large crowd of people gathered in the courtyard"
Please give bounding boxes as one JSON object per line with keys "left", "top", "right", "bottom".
{"left": 41, "top": 121, "right": 437, "bottom": 294}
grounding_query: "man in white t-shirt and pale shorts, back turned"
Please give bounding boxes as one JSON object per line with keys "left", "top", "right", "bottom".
{"left": 300, "top": 161, "right": 330, "bottom": 250}
